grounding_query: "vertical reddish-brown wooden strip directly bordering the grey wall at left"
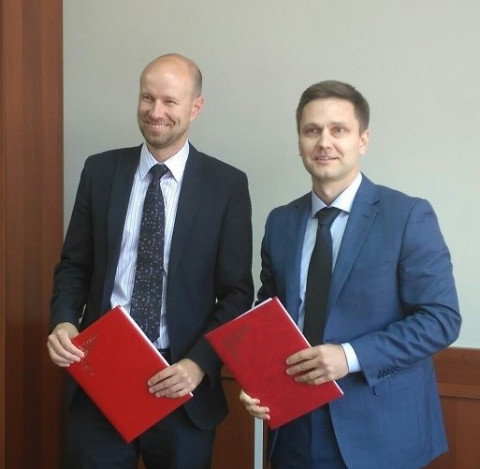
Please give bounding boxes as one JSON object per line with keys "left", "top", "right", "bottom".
{"left": 39, "top": 0, "right": 64, "bottom": 467}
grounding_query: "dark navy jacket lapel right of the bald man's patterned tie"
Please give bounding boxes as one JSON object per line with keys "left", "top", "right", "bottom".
{"left": 168, "top": 144, "right": 205, "bottom": 274}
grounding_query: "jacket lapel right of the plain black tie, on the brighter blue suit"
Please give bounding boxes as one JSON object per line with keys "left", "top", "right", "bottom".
{"left": 329, "top": 176, "right": 378, "bottom": 304}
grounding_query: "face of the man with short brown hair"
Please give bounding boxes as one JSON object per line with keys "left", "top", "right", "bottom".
{"left": 298, "top": 98, "right": 369, "bottom": 204}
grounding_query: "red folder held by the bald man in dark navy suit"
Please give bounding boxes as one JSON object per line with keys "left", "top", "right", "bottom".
{"left": 66, "top": 306, "right": 192, "bottom": 442}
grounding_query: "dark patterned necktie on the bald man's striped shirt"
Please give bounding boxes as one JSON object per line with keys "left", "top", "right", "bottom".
{"left": 130, "top": 164, "right": 168, "bottom": 342}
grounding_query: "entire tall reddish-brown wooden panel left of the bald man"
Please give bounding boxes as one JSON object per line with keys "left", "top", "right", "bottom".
{"left": 0, "top": 0, "right": 63, "bottom": 468}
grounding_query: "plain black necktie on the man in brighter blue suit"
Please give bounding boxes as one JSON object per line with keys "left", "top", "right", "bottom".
{"left": 303, "top": 207, "right": 340, "bottom": 345}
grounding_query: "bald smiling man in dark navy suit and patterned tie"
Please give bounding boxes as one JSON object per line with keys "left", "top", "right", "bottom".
{"left": 47, "top": 54, "right": 253, "bottom": 469}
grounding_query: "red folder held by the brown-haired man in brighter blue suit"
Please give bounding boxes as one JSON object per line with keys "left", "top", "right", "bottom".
{"left": 206, "top": 297, "right": 343, "bottom": 429}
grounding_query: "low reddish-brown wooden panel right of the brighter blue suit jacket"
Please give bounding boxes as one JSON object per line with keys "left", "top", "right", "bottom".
{"left": 428, "top": 347, "right": 480, "bottom": 469}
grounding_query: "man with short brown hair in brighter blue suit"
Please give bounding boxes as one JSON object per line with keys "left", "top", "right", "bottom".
{"left": 241, "top": 81, "right": 461, "bottom": 469}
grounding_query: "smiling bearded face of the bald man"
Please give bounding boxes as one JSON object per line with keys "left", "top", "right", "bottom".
{"left": 137, "top": 56, "right": 203, "bottom": 161}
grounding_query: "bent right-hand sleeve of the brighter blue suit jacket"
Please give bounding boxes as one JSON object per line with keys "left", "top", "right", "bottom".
{"left": 350, "top": 199, "right": 461, "bottom": 386}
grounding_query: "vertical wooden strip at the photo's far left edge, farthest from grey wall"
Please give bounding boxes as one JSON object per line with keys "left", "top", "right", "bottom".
{"left": 3, "top": 0, "right": 26, "bottom": 467}
